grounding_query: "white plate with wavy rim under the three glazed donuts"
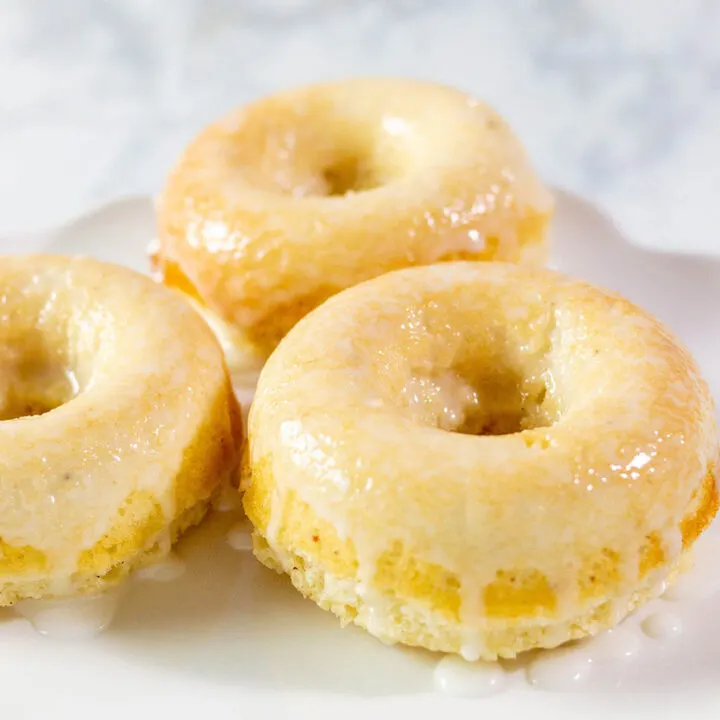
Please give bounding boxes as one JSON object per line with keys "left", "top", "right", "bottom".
{"left": 0, "top": 193, "right": 720, "bottom": 720}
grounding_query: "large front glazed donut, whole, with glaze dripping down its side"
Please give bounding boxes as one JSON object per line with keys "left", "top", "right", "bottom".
{"left": 242, "top": 262, "right": 718, "bottom": 660}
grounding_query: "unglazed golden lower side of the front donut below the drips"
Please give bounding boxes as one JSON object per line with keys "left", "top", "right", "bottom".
{"left": 244, "top": 464, "right": 718, "bottom": 661}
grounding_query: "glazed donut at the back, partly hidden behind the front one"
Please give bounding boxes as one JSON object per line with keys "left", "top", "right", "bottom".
{"left": 153, "top": 79, "right": 552, "bottom": 369}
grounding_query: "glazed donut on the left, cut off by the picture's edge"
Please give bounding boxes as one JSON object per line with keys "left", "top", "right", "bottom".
{"left": 0, "top": 255, "right": 242, "bottom": 605}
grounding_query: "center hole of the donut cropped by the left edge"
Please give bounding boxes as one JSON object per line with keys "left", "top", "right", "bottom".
{"left": 0, "top": 331, "right": 79, "bottom": 421}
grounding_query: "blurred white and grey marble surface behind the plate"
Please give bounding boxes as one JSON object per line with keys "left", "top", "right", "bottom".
{"left": 0, "top": 0, "right": 720, "bottom": 252}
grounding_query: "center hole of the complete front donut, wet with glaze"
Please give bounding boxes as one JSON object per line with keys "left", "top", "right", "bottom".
{"left": 370, "top": 288, "right": 565, "bottom": 436}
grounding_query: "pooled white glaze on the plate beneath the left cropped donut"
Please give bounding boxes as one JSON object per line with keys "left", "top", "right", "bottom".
{"left": 15, "top": 590, "right": 120, "bottom": 640}
